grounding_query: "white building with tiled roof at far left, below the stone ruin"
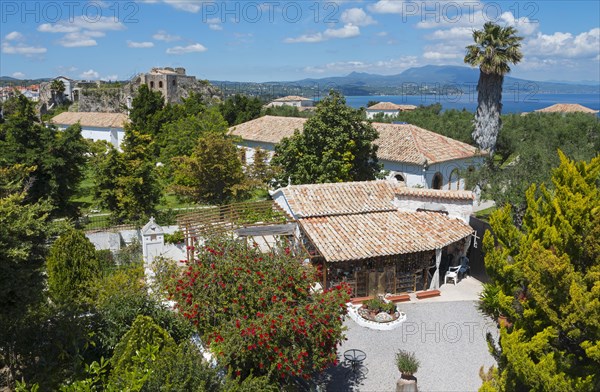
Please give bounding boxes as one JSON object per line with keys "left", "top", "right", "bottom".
{"left": 51, "top": 112, "right": 129, "bottom": 149}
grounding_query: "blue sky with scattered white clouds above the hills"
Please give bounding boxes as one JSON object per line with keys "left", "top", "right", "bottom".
{"left": 0, "top": 0, "right": 600, "bottom": 81}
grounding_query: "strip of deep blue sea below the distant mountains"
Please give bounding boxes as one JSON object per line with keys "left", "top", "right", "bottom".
{"left": 346, "top": 91, "right": 600, "bottom": 113}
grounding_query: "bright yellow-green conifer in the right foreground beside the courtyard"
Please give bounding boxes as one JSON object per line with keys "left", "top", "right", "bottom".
{"left": 483, "top": 152, "right": 600, "bottom": 391}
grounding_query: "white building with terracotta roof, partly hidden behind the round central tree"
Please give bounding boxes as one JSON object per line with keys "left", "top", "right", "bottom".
{"left": 230, "top": 116, "right": 484, "bottom": 190}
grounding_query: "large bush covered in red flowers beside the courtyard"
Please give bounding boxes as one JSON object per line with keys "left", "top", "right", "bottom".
{"left": 166, "top": 241, "right": 350, "bottom": 382}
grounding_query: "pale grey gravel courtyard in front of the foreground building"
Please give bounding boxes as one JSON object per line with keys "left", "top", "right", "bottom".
{"left": 327, "top": 301, "right": 498, "bottom": 392}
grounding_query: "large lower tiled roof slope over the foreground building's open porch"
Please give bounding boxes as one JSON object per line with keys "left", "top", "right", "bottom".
{"left": 300, "top": 211, "right": 473, "bottom": 262}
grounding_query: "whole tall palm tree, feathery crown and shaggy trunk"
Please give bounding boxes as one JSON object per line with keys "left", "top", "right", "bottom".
{"left": 465, "top": 22, "right": 523, "bottom": 155}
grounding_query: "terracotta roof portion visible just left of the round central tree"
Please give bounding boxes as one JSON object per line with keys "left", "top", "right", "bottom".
{"left": 229, "top": 116, "right": 306, "bottom": 144}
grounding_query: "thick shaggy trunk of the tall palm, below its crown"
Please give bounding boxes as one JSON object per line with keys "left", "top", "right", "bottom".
{"left": 472, "top": 71, "right": 504, "bottom": 156}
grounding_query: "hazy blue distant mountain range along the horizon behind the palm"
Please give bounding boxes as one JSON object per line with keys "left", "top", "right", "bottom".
{"left": 211, "top": 65, "right": 600, "bottom": 95}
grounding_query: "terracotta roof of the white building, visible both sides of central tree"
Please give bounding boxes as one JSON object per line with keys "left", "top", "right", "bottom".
{"left": 229, "top": 116, "right": 482, "bottom": 165}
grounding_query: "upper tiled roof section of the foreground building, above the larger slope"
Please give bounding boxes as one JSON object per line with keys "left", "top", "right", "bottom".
{"left": 281, "top": 180, "right": 404, "bottom": 217}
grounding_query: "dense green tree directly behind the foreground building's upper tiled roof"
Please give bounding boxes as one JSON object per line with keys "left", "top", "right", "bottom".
{"left": 271, "top": 91, "right": 381, "bottom": 184}
